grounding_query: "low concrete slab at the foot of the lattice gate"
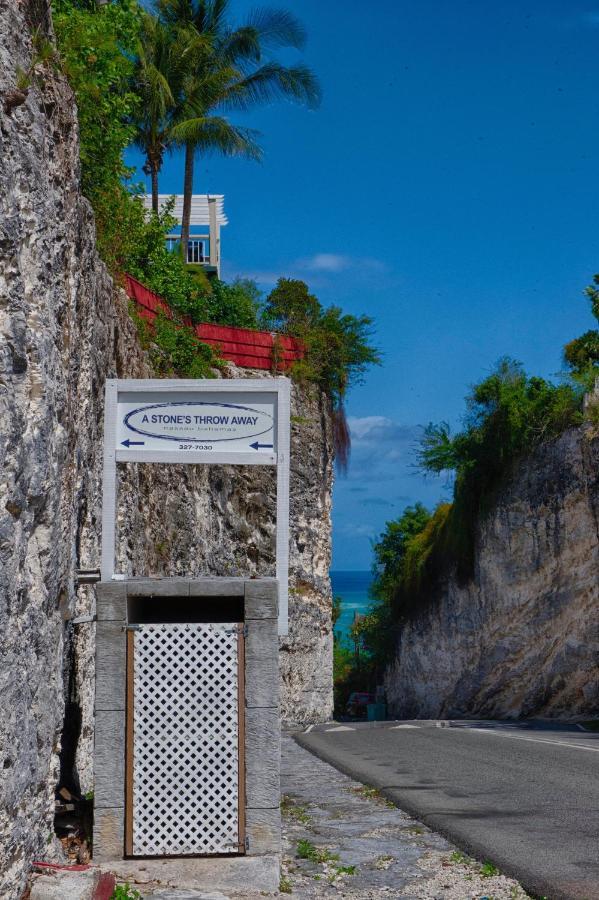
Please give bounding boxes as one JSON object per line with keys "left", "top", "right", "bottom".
{"left": 101, "top": 855, "right": 281, "bottom": 897}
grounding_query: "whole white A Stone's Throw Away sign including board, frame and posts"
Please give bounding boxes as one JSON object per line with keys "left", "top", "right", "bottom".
{"left": 102, "top": 377, "right": 289, "bottom": 634}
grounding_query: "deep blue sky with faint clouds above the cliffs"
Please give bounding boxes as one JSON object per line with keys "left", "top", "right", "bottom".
{"left": 130, "top": 0, "right": 599, "bottom": 569}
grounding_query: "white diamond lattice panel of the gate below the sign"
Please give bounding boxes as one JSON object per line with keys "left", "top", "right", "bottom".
{"left": 133, "top": 624, "right": 239, "bottom": 856}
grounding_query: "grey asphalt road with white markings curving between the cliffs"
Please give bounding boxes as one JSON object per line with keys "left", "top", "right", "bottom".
{"left": 296, "top": 721, "right": 599, "bottom": 900}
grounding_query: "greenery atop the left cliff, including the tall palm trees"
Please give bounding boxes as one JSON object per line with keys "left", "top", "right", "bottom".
{"left": 53, "top": 0, "right": 380, "bottom": 428}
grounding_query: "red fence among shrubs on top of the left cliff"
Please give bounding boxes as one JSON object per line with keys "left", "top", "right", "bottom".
{"left": 125, "top": 275, "right": 304, "bottom": 371}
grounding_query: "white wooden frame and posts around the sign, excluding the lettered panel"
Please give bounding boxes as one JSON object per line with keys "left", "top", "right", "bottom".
{"left": 101, "top": 376, "right": 291, "bottom": 635}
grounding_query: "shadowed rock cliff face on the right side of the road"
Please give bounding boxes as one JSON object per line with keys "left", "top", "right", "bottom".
{"left": 386, "top": 429, "right": 599, "bottom": 718}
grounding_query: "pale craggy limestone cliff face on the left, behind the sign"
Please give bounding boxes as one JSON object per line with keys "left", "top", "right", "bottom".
{"left": 0, "top": 0, "right": 332, "bottom": 898}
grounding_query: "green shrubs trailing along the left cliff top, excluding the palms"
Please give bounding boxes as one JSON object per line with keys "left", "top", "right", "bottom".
{"left": 49, "top": 0, "right": 380, "bottom": 414}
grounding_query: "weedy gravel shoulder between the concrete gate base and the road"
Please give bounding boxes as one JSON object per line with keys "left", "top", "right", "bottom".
{"left": 279, "top": 734, "right": 528, "bottom": 900}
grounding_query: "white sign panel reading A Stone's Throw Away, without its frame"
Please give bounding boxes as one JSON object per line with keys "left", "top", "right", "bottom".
{"left": 115, "top": 391, "right": 277, "bottom": 462}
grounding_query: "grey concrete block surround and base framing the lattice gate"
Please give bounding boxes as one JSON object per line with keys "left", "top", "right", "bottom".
{"left": 93, "top": 578, "right": 281, "bottom": 892}
